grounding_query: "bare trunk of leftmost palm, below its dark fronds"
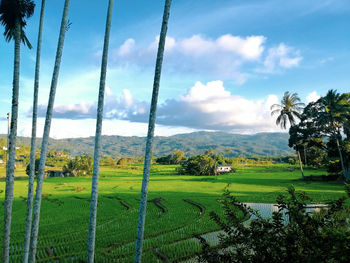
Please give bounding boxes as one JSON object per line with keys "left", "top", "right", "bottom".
{"left": 3, "top": 19, "right": 21, "bottom": 263}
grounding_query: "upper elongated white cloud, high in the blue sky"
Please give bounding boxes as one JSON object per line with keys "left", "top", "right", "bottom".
{"left": 111, "top": 34, "right": 302, "bottom": 84}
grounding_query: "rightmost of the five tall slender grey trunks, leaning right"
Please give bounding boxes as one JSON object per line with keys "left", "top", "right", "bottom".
{"left": 134, "top": 0, "right": 171, "bottom": 263}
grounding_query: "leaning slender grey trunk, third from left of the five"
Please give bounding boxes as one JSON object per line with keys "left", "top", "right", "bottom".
{"left": 29, "top": 0, "right": 70, "bottom": 262}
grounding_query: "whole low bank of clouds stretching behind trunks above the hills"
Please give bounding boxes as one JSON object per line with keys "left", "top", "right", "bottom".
{"left": 34, "top": 80, "right": 278, "bottom": 133}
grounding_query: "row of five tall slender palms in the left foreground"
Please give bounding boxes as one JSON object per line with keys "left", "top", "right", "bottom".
{"left": 0, "top": 0, "right": 171, "bottom": 263}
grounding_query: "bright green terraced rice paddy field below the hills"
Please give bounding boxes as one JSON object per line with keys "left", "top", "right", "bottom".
{"left": 0, "top": 165, "right": 345, "bottom": 262}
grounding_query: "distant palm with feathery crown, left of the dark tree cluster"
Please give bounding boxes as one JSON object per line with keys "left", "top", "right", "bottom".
{"left": 271, "top": 91, "right": 305, "bottom": 179}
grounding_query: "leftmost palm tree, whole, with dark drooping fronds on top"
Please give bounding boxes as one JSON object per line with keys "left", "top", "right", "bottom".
{"left": 0, "top": 0, "right": 35, "bottom": 263}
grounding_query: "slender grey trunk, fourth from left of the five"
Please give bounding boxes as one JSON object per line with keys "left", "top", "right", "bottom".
{"left": 87, "top": 0, "right": 114, "bottom": 263}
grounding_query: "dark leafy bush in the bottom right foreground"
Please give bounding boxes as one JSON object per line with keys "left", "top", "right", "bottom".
{"left": 199, "top": 185, "right": 350, "bottom": 263}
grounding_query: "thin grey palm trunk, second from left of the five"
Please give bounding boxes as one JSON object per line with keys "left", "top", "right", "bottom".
{"left": 23, "top": 0, "right": 45, "bottom": 263}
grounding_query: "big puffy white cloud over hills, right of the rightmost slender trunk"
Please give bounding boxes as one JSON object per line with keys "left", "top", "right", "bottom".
{"left": 159, "top": 81, "right": 278, "bottom": 132}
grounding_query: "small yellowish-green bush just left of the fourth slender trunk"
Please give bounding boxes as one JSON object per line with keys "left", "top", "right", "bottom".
{"left": 63, "top": 155, "right": 93, "bottom": 176}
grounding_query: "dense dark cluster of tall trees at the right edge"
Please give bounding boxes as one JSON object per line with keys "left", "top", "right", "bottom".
{"left": 289, "top": 90, "right": 350, "bottom": 181}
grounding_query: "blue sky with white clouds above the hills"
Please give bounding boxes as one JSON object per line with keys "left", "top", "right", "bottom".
{"left": 0, "top": 0, "right": 350, "bottom": 139}
